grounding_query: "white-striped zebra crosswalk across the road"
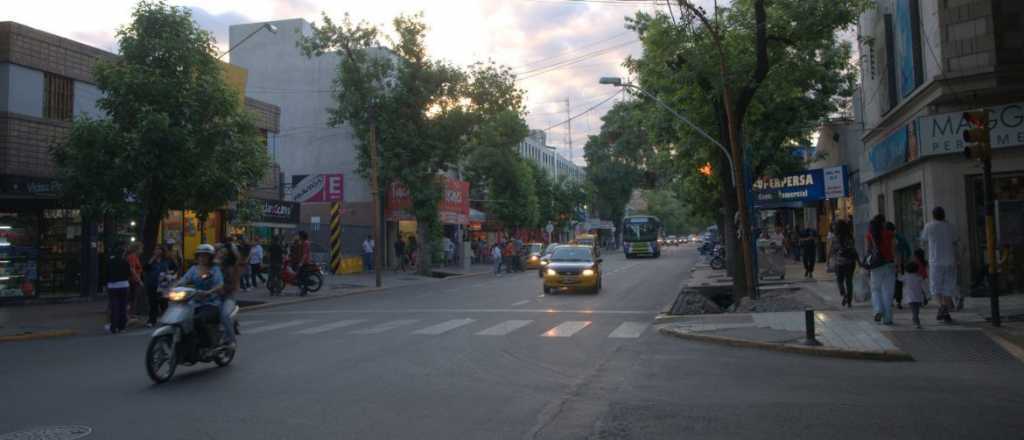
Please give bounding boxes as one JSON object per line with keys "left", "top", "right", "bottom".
{"left": 231, "top": 317, "right": 650, "bottom": 340}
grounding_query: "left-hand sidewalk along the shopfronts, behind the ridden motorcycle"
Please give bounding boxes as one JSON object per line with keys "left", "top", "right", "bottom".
{"left": 0, "top": 265, "right": 493, "bottom": 343}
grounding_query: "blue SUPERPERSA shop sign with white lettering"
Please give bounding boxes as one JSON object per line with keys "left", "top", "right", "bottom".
{"left": 752, "top": 166, "right": 850, "bottom": 207}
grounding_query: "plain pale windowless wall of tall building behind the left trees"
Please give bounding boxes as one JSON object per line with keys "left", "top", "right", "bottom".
{"left": 229, "top": 18, "right": 371, "bottom": 203}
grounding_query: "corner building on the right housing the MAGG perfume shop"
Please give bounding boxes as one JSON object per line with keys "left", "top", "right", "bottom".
{"left": 856, "top": 0, "right": 1024, "bottom": 292}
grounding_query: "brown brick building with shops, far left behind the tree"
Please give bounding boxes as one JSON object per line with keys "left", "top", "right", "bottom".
{"left": 0, "top": 21, "right": 281, "bottom": 300}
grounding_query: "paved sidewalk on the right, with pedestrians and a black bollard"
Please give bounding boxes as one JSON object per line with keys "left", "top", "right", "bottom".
{"left": 660, "top": 260, "right": 1024, "bottom": 361}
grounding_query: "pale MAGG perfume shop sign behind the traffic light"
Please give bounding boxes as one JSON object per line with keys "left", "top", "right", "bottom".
{"left": 919, "top": 103, "right": 1024, "bottom": 156}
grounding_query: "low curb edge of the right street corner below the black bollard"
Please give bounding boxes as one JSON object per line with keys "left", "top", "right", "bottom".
{"left": 658, "top": 323, "right": 914, "bottom": 361}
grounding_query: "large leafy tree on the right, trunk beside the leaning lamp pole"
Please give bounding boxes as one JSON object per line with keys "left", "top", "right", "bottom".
{"left": 627, "top": 0, "right": 868, "bottom": 296}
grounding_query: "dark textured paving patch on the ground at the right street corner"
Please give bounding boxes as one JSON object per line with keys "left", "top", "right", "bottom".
{"left": 886, "top": 331, "right": 1016, "bottom": 362}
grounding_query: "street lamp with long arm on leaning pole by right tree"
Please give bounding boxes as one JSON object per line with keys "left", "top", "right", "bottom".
{"left": 598, "top": 77, "right": 757, "bottom": 298}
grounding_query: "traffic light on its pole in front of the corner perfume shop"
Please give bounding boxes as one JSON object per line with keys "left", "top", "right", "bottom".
{"left": 964, "top": 108, "right": 1002, "bottom": 326}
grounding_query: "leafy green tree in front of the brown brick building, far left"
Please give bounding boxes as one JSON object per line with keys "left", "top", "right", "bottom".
{"left": 53, "top": 1, "right": 269, "bottom": 254}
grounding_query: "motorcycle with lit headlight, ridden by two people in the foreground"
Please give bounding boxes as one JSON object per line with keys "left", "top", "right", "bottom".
{"left": 145, "top": 288, "right": 239, "bottom": 384}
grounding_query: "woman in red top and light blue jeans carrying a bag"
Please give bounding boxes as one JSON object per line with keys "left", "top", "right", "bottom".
{"left": 864, "top": 214, "right": 896, "bottom": 325}
